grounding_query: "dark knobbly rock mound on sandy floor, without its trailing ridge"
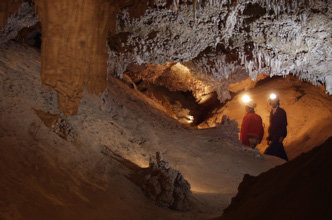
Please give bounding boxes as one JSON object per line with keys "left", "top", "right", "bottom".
{"left": 142, "top": 152, "right": 191, "bottom": 211}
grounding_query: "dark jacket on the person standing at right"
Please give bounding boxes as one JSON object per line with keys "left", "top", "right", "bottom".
{"left": 267, "top": 107, "right": 287, "bottom": 141}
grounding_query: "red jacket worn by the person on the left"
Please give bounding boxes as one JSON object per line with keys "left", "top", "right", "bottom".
{"left": 240, "top": 112, "right": 264, "bottom": 146}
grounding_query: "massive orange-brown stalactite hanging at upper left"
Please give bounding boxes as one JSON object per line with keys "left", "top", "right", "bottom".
{"left": 35, "top": 0, "right": 111, "bottom": 115}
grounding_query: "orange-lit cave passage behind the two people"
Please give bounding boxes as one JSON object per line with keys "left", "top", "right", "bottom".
{"left": 126, "top": 63, "right": 332, "bottom": 159}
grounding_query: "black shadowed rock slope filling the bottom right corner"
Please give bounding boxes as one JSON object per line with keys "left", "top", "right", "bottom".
{"left": 218, "top": 137, "right": 332, "bottom": 220}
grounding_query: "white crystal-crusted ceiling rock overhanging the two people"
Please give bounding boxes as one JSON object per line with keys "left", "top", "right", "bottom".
{"left": 108, "top": 0, "right": 332, "bottom": 101}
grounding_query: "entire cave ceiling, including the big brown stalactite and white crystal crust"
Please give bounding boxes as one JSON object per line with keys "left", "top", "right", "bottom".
{"left": 0, "top": 0, "right": 332, "bottom": 115}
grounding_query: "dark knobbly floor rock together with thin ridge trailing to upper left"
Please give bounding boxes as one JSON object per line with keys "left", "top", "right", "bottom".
{"left": 102, "top": 146, "right": 193, "bottom": 211}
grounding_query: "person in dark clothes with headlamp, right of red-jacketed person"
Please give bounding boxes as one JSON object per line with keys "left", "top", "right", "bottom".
{"left": 264, "top": 94, "right": 288, "bottom": 161}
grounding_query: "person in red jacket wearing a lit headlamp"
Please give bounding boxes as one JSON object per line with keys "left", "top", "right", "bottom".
{"left": 240, "top": 100, "right": 264, "bottom": 148}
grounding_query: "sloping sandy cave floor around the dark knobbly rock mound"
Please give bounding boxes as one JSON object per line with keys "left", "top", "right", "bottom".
{"left": 0, "top": 42, "right": 326, "bottom": 220}
